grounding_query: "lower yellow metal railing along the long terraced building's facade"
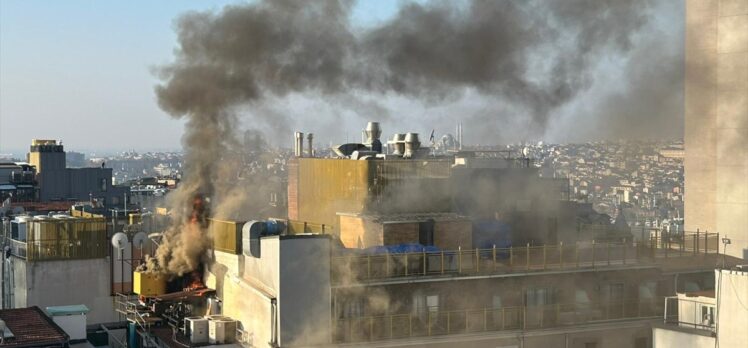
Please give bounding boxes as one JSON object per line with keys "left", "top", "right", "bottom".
{"left": 333, "top": 300, "right": 662, "bottom": 343}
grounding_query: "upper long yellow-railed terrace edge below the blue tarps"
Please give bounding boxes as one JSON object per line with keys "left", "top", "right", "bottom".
{"left": 331, "top": 233, "right": 718, "bottom": 284}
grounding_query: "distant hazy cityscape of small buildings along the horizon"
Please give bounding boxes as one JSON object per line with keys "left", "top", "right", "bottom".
{"left": 13, "top": 140, "right": 684, "bottom": 232}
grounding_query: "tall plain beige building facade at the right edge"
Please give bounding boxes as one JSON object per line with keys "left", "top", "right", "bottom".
{"left": 685, "top": 0, "right": 748, "bottom": 258}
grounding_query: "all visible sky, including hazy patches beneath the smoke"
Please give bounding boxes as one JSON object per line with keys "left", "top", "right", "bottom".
{"left": 0, "top": 0, "right": 683, "bottom": 155}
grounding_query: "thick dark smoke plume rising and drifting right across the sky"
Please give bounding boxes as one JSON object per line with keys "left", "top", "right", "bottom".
{"left": 156, "top": 0, "right": 668, "bottom": 274}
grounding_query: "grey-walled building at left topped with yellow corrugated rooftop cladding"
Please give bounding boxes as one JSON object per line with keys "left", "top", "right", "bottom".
{"left": 0, "top": 215, "right": 116, "bottom": 323}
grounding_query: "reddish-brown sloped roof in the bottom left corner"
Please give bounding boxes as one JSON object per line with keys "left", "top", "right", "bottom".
{"left": 0, "top": 306, "right": 69, "bottom": 348}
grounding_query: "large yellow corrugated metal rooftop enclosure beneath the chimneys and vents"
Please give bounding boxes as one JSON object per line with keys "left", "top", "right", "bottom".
{"left": 296, "top": 158, "right": 452, "bottom": 230}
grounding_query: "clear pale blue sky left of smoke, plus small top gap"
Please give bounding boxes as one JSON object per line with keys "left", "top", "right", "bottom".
{"left": 0, "top": 0, "right": 410, "bottom": 153}
